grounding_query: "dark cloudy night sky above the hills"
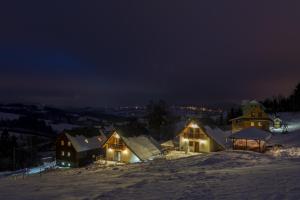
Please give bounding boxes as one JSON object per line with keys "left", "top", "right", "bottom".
{"left": 0, "top": 0, "right": 300, "bottom": 106}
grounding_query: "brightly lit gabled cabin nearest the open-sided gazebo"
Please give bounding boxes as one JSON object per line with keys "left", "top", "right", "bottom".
{"left": 179, "top": 120, "right": 225, "bottom": 153}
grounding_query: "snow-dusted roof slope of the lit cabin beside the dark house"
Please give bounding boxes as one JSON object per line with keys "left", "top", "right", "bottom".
{"left": 121, "top": 135, "right": 161, "bottom": 161}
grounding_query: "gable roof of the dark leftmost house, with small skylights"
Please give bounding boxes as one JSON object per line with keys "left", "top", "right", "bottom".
{"left": 64, "top": 128, "right": 106, "bottom": 152}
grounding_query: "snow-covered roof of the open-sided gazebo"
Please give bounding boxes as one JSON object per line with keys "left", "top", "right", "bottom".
{"left": 229, "top": 127, "right": 272, "bottom": 140}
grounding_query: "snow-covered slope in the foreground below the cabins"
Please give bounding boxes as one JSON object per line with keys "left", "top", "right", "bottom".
{"left": 0, "top": 151, "right": 300, "bottom": 200}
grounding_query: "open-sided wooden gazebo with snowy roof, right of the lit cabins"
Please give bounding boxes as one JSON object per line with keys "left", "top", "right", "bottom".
{"left": 229, "top": 127, "right": 272, "bottom": 152}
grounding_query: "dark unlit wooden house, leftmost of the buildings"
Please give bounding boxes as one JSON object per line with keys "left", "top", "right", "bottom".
{"left": 56, "top": 128, "right": 106, "bottom": 167}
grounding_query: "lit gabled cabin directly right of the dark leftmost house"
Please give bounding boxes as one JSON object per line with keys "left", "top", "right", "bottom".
{"left": 103, "top": 128, "right": 161, "bottom": 163}
